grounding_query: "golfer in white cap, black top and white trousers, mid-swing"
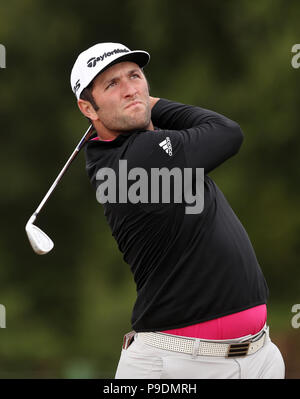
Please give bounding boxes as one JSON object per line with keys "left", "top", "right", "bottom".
{"left": 71, "top": 43, "right": 284, "bottom": 379}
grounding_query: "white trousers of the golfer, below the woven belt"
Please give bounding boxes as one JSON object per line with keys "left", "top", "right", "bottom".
{"left": 115, "top": 331, "right": 285, "bottom": 379}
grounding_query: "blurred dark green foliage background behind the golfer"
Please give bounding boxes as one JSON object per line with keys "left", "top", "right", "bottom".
{"left": 0, "top": 0, "right": 300, "bottom": 378}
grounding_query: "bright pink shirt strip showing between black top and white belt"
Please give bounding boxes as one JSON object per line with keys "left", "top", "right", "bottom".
{"left": 161, "top": 304, "right": 267, "bottom": 340}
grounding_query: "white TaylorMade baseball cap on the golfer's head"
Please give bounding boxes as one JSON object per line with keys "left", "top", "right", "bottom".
{"left": 71, "top": 43, "right": 150, "bottom": 99}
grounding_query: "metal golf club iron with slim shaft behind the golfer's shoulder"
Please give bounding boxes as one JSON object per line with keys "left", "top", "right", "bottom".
{"left": 25, "top": 125, "right": 94, "bottom": 255}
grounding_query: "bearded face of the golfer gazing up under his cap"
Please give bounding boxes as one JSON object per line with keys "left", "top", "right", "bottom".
{"left": 92, "top": 62, "right": 151, "bottom": 132}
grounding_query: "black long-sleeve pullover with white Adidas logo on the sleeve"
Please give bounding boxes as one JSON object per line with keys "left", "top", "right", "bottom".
{"left": 86, "top": 99, "right": 268, "bottom": 331}
